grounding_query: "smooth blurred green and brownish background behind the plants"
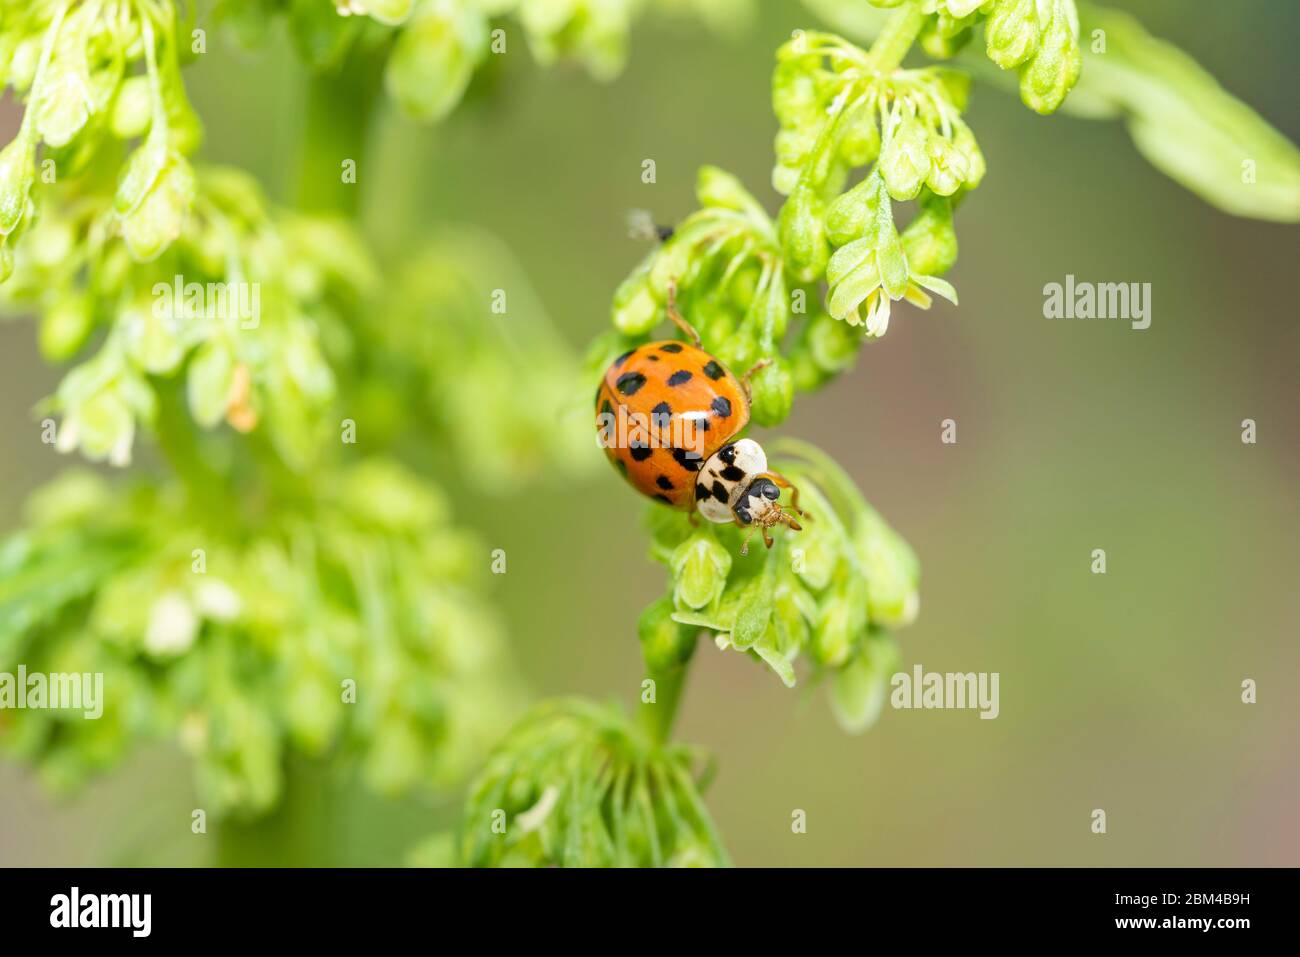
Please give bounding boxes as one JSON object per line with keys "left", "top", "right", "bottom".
{"left": 0, "top": 0, "right": 1300, "bottom": 866}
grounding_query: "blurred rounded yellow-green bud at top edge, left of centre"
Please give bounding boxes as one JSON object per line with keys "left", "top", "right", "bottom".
{"left": 387, "top": 7, "right": 488, "bottom": 121}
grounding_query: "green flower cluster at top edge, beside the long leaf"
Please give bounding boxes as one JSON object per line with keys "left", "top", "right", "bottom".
{"left": 871, "top": 0, "right": 1083, "bottom": 113}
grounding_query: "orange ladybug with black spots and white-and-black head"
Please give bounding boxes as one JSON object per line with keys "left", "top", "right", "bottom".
{"left": 595, "top": 285, "right": 806, "bottom": 554}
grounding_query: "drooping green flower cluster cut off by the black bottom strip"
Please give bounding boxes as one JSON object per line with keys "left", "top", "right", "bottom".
{"left": 447, "top": 700, "right": 729, "bottom": 867}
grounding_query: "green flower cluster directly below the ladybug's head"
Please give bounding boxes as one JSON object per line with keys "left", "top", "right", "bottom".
{"left": 641, "top": 439, "right": 920, "bottom": 731}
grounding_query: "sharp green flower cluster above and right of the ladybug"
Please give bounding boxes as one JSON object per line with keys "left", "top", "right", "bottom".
{"left": 772, "top": 33, "right": 985, "bottom": 337}
